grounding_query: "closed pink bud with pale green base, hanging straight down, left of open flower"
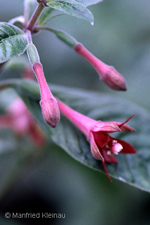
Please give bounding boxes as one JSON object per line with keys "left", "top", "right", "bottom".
{"left": 27, "top": 43, "right": 60, "bottom": 127}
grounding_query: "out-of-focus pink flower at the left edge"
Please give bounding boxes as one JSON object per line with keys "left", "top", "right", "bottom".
{"left": 0, "top": 98, "right": 45, "bottom": 146}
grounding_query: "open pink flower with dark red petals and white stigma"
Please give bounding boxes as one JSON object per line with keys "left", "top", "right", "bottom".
{"left": 57, "top": 100, "right": 136, "bottom": 181}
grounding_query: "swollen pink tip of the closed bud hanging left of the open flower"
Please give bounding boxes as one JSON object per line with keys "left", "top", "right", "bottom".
{"left": 40, "top": 97, "right": 60, "bottom": 127}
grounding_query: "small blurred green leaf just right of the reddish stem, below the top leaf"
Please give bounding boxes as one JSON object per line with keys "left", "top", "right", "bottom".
{"left": 38, "top": 8, "right": 54, "bottom": 26}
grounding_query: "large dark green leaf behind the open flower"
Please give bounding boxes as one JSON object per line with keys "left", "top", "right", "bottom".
{"left": 0, "top": 79, "right": 150, "bottom": 192}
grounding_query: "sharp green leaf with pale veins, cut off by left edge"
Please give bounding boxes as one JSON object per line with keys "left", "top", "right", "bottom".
{"left": 0, "top": 22, "right": 28, "bottom": 63}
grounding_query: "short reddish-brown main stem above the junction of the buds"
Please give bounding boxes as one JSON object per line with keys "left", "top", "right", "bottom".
{"left": 26, "top": 4, "right": 44, "bottom": 31}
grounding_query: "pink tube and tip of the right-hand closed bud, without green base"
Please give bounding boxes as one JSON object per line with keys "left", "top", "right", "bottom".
{"left": 74, "top": 43, "right": 127, "bottom": 91}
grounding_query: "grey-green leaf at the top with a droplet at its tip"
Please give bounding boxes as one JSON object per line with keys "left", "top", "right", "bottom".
{"left": 47, "top": 0, "right": 94, "bottom": 25}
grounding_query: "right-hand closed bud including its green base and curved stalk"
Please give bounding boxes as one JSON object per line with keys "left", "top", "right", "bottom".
{"left": 34, "top": 26, "right": 127, "bottom": 91}
